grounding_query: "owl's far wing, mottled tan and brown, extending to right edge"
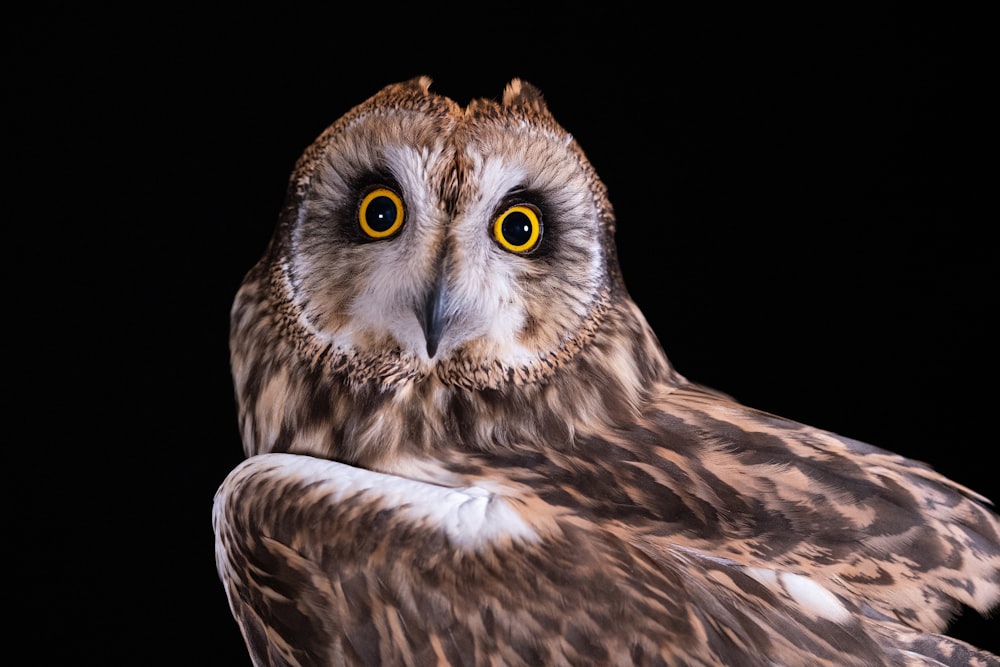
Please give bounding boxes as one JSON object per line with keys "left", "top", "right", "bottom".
{"left": 634, "top": 385, "right": 1000, "bottom": 632}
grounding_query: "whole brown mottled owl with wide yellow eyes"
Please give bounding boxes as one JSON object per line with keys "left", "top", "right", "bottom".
{"left": 213, "top": 77, "right": 1000, "bottom": 667}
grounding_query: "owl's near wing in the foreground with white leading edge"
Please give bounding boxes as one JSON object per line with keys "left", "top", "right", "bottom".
{"left": 214, "top": 446, "right": 997, "bottom": 667}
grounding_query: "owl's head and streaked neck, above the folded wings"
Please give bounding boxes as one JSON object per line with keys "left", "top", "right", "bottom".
{"left": 231, "top": 77, "right": 668, "bottom": 460}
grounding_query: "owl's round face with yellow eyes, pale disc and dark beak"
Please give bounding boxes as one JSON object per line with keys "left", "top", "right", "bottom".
{"left": 281, "top": 79, "right": 608, "bottom": 392}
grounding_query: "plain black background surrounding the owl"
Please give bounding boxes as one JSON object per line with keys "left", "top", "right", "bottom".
{"left": 0, "top": 3, "right": 1000, "bottom": 665}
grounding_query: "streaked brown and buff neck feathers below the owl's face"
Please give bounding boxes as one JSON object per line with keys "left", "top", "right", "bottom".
{"left": 232, "top": 280, "right": 683, "bottom": 470}
